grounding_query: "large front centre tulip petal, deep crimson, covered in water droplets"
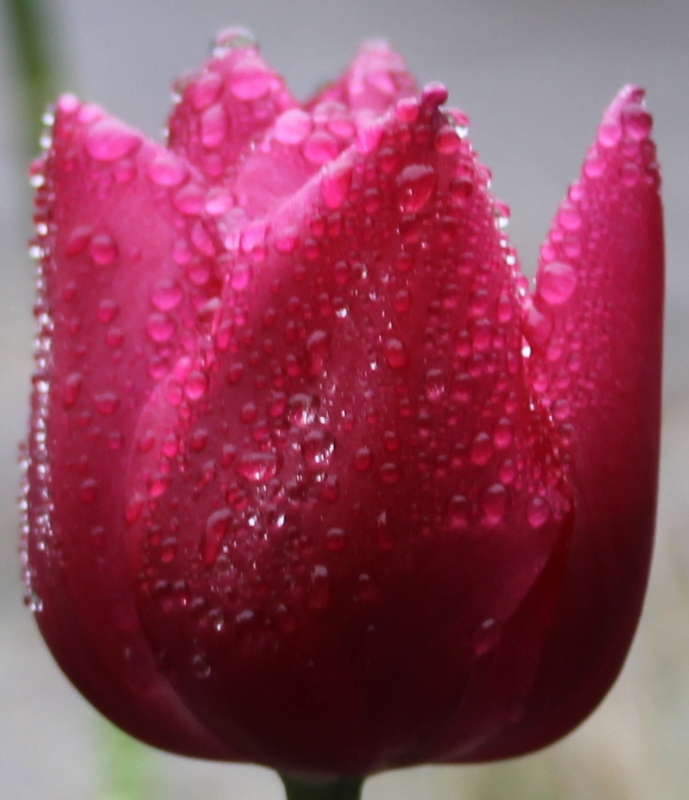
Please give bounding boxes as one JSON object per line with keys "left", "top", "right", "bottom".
{"left": 123, "top": 87, "right": 569, "bottom": 774}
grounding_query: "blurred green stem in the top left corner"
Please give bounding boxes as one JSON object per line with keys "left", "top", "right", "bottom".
{"left": 2, "top": 0, "right": 58, "bottom": 151}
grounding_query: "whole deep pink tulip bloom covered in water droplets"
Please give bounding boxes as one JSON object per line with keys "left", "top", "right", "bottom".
{"left": 24, "top": 29, "right": 663, "bottom": 798}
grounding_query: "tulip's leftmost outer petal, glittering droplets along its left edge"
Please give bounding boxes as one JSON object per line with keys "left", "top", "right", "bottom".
{"left": 27, "top": 96, "right": 231, "bottom": 757}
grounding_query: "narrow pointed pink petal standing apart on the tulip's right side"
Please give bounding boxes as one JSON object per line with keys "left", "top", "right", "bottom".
{"left": 472, "top": 87, "right": 663, "bottom": 758}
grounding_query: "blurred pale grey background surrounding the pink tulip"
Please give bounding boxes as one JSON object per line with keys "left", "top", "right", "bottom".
{"left": 0, "top": 0, "right": 689, "bottom": 800}
